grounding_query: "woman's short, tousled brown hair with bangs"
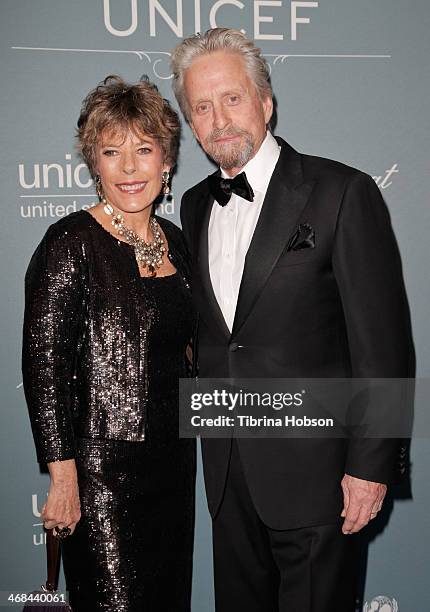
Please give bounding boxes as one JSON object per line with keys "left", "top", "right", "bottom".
{"left": 77, "top": 75, "right": 181, "bottom": 177}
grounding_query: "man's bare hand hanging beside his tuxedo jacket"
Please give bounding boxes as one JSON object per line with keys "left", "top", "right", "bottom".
{"left": 341, "top": 474, "right": 387, "bottom": 534}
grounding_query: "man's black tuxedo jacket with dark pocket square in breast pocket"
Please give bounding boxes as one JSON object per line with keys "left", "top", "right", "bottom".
{"left": 181, "top": 138, "right": 415, "bottom": 529}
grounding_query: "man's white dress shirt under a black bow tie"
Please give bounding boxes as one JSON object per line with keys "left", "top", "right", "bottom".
{"left": 208, "top": 131, "right": 280, "bottom": 332}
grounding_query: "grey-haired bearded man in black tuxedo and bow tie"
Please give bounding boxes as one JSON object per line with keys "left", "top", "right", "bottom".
{"left": 172, "top": 28, "right": 414, "bottom": 612}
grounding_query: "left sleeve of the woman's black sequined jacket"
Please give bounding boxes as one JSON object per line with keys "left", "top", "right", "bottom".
{"left": 22, "top": 224, "right": 83, "bottom": 463}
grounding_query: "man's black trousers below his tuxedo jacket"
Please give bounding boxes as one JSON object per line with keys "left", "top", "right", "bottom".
{"left": 213, "top": 440, "right": 358, "bottom": 612}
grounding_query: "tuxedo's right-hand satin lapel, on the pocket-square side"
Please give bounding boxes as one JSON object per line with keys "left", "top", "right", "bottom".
{"left": 232, "top": 138, "right": 314, "bottom": 337}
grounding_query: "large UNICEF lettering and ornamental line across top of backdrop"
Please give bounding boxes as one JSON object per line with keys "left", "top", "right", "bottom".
{"left": 12, "top": 0, "right": 391, "bottom": 80}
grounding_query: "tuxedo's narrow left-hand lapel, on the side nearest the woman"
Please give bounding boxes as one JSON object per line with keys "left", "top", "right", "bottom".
{"left": 195, "top": 179, "right": 230, "bottom": 338}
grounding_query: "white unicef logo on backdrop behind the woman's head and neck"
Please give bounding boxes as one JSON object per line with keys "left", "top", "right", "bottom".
{"left": 18, "top": 153, "right": 175, "bottom": 219}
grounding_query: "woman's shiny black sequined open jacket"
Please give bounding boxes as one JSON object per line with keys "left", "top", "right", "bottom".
{"left": 22, "top": 210, "right": 193, "bottom": 463}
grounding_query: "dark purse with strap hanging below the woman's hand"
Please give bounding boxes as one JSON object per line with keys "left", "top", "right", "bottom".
{"left": 23, "top": 529, "right": 73, "bottom": 612}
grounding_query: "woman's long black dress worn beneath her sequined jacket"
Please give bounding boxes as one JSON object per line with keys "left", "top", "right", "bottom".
{"left": 62, "top": 274, "right": 195, "bottom": 612}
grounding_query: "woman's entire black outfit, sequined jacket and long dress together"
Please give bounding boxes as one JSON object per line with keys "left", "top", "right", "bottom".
{"left": 22, "top": 211, "right": 195, "bottom": 612}
